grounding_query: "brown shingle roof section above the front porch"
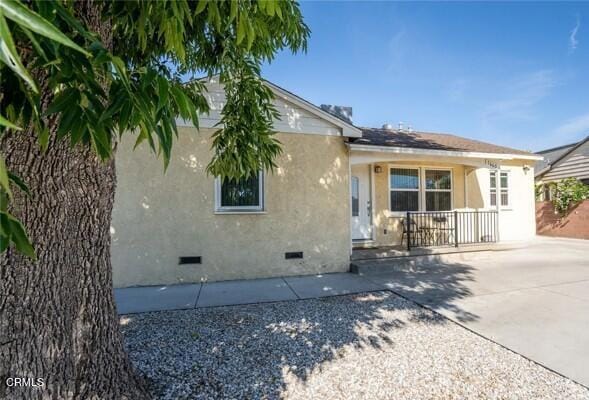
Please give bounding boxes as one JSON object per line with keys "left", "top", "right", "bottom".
{"left": 351, "top": 128, "right": 534, "bottom": 155}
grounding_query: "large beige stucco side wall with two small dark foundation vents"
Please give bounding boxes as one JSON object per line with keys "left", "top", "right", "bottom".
{"left": 111, "top": 128, "right": 350, "bottom": 287}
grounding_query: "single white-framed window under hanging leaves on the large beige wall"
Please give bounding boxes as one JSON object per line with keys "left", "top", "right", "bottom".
{"left": 215, "top": 172, "right": 264, "bottom": 212}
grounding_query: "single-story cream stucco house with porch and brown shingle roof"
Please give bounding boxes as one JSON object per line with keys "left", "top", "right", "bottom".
{"left": 111, "top": 81, "right": 540, "bottom": 287}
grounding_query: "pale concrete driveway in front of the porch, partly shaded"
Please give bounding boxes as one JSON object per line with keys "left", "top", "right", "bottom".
{"left": 365, "top": 237, "right": 589, "bottom": 386}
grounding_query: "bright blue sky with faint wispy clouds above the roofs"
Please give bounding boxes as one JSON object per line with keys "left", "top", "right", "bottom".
{"left": 262, "top": 1, "right": 589, "bottom": 151}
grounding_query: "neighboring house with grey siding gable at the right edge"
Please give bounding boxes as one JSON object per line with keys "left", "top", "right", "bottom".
{"left": 535, "top": 136, "right": 589, "bottom": 200}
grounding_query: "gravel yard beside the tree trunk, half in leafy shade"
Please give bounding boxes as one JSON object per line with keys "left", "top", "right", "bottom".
{"left": 121, "top": 292, "right": 589, "bottom": 400}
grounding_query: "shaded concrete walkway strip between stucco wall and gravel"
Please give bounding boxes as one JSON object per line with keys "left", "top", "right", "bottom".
{"left": 114, "top": 273, "right": 387, "bottom": 314}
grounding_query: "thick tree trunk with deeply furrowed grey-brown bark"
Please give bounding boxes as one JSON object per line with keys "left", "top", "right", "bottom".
{"left": 0, "top": 2, "right": 148, "bottom": 399}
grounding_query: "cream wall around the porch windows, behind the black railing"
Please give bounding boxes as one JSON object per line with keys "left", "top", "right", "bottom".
{"left": 366, "top": 161, "right": 536, "bottom": 246}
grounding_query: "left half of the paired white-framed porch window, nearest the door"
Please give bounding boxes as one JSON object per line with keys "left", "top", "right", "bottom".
{"left": 390, "top": 168, "right": 419, "bottom": 211}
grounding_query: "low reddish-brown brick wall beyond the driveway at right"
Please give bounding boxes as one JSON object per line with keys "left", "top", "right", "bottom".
{"left": 536, "top": 200, "right": 589, "bottom": 239}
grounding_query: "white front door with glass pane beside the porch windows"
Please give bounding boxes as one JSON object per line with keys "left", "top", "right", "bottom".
{"left": 351, "top": 165, "right": 372, "bottom": 240}
